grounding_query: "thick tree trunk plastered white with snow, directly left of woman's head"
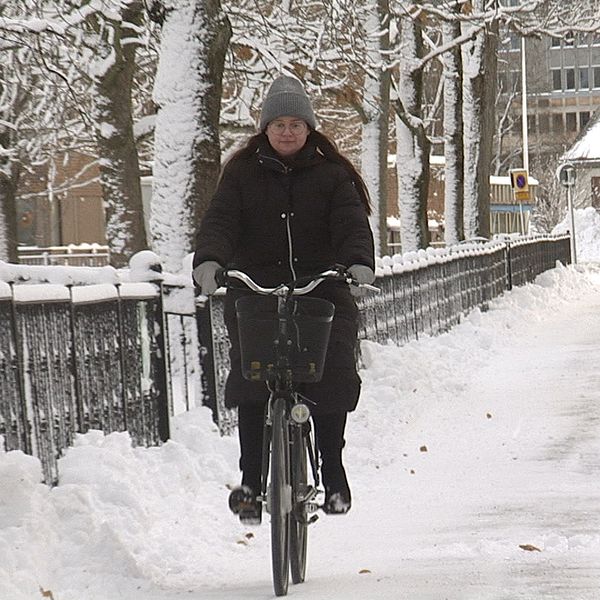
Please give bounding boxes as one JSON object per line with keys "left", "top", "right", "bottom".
{"left": 151, "top": 0, "right": 231, "bottom": 271}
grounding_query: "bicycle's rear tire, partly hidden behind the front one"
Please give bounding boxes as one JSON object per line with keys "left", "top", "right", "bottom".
{"left": 290, "top": 426, "right": 308, "bottom": 583}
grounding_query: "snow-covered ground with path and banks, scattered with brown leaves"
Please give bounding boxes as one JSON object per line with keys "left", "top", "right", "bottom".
{"left": 0, "top": 209, "right": 600, "bottom": 600}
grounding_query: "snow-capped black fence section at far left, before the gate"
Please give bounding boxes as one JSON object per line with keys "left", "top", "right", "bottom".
{"left": 0, "top": 274, "right": 169, "bottom": 483}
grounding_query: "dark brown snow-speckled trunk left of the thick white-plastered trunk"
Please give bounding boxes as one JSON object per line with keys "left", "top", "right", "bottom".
{"left": 94, "top": 2, "right": 148, "bottom": 267}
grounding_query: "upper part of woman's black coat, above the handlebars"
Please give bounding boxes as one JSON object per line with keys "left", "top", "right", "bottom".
{"left": 194, "top": 138, "right": 374, "bottom": 286}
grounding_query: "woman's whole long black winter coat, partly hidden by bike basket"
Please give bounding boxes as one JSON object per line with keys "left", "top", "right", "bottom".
{"left": 194, "top": 138, "right": 374, "bottom": 413}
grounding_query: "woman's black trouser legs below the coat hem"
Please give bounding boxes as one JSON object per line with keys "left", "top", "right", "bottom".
{"left": 238, "top": 404, "right": 350, "bottom": 499}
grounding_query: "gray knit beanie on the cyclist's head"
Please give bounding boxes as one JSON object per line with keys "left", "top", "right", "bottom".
{"left": 259, "top": 75, "right": 317, "bottom": 131}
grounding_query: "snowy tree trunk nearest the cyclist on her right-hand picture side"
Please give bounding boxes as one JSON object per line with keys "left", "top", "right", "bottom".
{"left": 362, "top": 0, "right": 390, "bottom": 256}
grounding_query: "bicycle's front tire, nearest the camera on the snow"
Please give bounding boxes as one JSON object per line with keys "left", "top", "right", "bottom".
{"left": 269, "top": 398, "right": 292, "bottom": 596}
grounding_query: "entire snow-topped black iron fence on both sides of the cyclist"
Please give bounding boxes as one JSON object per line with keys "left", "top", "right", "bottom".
{"left": 0, "top": 236, "right": 571, "bottom": 483}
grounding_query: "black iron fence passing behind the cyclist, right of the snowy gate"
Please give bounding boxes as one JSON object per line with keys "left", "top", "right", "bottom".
{"left": 196, "top": 236, "right": 571, "bottom": 433}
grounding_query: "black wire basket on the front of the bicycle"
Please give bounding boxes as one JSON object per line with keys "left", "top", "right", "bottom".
{"left": 235, "top": 296, "right": 335, "bottom": 383}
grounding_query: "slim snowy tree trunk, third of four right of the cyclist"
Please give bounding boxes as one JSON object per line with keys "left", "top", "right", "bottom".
{"left": 442, "top": 7, "right": 464, "bottom": 246}
